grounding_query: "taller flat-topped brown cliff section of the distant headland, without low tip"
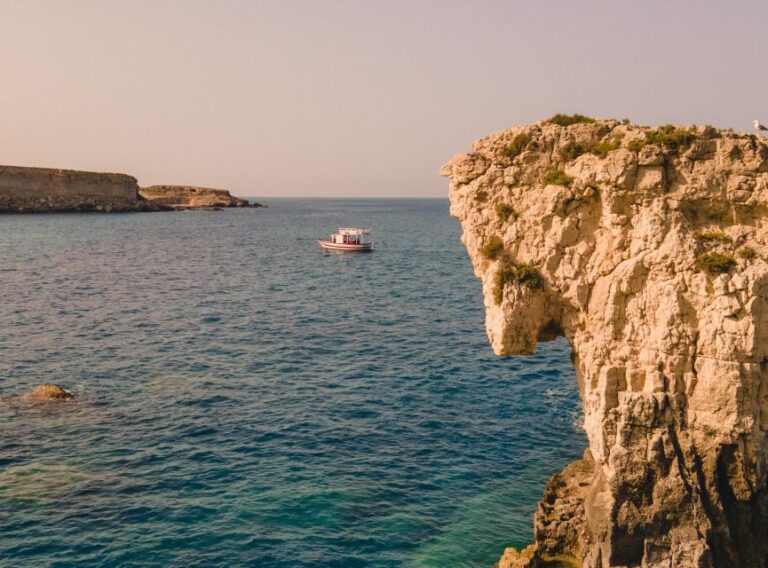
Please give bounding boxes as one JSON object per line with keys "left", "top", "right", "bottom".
{"left": 0, "top": 166, "right": 147, "bottom": 213}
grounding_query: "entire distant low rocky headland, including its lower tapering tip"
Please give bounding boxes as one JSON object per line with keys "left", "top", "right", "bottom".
{"left": 0, "top": 166, "right": 264, "bottom": 213}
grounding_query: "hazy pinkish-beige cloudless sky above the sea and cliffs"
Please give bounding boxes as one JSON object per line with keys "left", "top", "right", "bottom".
{"left": 0, "top": 0, "right": 768, "bottom": 197}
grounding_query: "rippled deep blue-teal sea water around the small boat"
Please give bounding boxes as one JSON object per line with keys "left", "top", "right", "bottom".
{"left": 0, "top": 200, "right": 586, "bottom": 568}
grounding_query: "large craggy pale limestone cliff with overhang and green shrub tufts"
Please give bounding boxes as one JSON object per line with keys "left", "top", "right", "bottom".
{"left": 442, "top": 120, "right": 768, "bottom": 568}
